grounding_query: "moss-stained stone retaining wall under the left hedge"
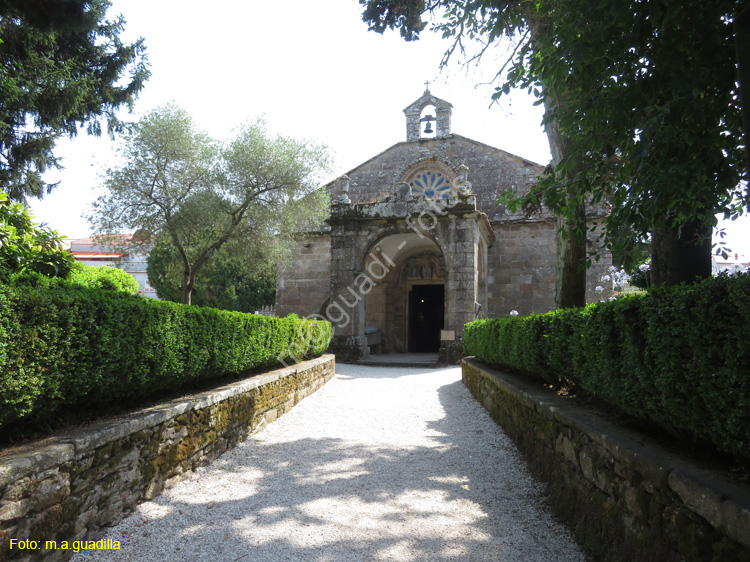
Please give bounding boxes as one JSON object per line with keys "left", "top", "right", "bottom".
{"left": 0, "top": 355, "right": 335, "bottom": 561}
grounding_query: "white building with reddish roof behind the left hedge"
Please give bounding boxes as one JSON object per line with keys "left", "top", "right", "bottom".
{"left": 68, "top": 234, "right": 158, "bottom": 299}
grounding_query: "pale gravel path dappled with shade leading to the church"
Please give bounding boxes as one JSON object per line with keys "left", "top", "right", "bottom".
{"left": 72, "top": 365, "right": 585, "bottom": 562}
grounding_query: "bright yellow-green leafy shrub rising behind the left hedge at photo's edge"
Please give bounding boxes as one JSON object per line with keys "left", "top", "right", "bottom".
{"left": 0, "top": 193, "right": 75, "bottom": 281}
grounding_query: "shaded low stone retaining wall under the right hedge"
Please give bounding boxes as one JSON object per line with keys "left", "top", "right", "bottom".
{"left": 462, "top": 359, "right": 750, "bottom": 562}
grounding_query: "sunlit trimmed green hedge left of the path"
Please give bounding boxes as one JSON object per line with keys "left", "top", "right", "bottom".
{"left": 0, "top": 284, "right": 331, "bottom": 429}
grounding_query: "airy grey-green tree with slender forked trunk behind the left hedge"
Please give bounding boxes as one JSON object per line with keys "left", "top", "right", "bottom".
{"left": 89, "top": 105, "right": 328, "bottom": 304}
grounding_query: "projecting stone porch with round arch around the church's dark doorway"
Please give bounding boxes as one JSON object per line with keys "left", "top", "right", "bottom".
{"left": 326, "top": 184, "right": 492, "bottom": 362}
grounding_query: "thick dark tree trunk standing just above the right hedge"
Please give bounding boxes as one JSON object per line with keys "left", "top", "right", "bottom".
{"left": 651, "top": 220, "right": 713, "bottom": 287}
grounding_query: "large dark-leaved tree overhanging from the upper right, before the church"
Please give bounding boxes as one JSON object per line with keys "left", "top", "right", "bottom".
{"left": 361, "top": 0, "right": 750, "bottom": 294}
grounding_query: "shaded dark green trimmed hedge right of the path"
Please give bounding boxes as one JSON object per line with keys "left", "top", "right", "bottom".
{"left": 464, "top": 274, "right": 750, "bottom": 460}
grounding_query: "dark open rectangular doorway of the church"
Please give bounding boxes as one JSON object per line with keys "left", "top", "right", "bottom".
{"left": 409, "top": 285, "right": 445, "bottom": 353}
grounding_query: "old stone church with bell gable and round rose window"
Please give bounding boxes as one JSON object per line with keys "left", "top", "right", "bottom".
{"left": 276, "top": 90, "right": 611, "bottom": 360}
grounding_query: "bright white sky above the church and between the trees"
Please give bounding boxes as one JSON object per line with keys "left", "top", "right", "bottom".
{"left": 26, "top": 0, "right": 750, "bottom": 254}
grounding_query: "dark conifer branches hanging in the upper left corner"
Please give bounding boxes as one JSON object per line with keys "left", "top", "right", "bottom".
{"left": 0, "top": 0, "right": 149, "bottom": 201}
